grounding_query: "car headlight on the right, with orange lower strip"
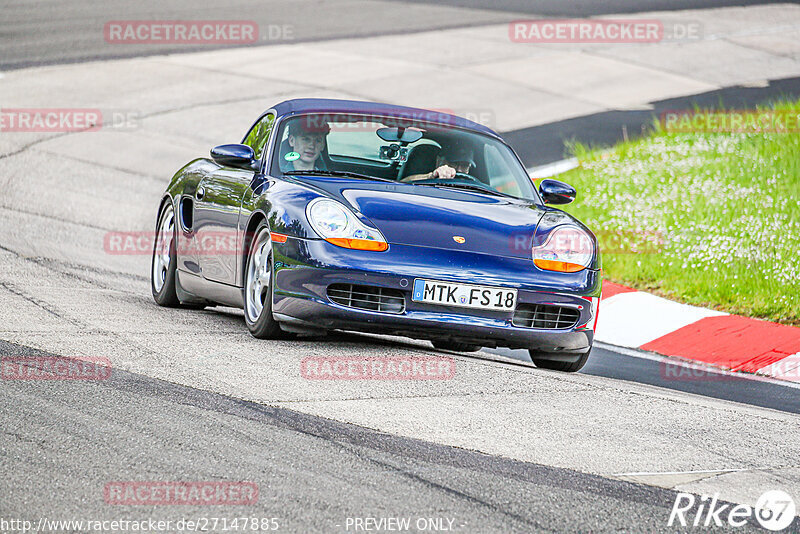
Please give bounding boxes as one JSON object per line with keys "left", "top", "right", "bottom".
{"left": 533, "top": 225, "right": 594, "bottom": 273}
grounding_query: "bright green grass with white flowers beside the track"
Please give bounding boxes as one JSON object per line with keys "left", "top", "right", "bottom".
{"left": 558, "top": 102, "right": 800, "bottom": 325}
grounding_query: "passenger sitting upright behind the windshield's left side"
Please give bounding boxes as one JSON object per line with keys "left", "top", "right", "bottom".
{"left": 280, "top": 119, "right": 331, "bottom": 172}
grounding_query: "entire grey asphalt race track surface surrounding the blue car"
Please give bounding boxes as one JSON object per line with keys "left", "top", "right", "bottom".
{"left": 0, "top": 0, "right": 800, "bottom": 533}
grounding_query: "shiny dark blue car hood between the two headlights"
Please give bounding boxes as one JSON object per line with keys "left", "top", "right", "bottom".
{"left": 296, "top": 180, "right": 546, "bottom": 258}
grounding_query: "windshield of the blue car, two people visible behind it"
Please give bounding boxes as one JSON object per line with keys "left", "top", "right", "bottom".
{"left": 271, "top": 113, "right": 538, "bottom": 200}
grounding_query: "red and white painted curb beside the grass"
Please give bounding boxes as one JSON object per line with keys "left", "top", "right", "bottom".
{"left": 595, "top": 282, "right": 800, "bottom": 383}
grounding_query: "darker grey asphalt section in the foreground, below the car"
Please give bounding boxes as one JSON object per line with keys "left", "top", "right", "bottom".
{"left": 2, "top": 345, "right": 748, "bottom": 532}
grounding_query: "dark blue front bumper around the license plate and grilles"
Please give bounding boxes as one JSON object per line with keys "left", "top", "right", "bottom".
{"left": 273, "top": 238, "right": 601, "bottom": 354}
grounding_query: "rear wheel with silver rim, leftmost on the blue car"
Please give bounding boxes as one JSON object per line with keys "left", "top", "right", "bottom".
{"left": 150, "top": 201, "right": 180, "bottom": 308}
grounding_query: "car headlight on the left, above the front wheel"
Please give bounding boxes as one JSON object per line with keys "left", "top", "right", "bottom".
{"left": 306, "top": 198, "right": 389, "bottom": 252}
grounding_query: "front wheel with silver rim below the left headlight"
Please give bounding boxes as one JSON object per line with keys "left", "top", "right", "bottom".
{"left": 242, "top": 221, "right": 285, "bottom": 339}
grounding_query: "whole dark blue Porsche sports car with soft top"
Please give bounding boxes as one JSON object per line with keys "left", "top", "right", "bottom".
{"left": 151, "top": 99, "right": 601, "bottom": 371}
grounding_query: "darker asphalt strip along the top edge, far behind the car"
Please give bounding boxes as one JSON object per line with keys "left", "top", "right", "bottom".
{"left": 0, "top": 0, "right": 788, "bottom": 70}
